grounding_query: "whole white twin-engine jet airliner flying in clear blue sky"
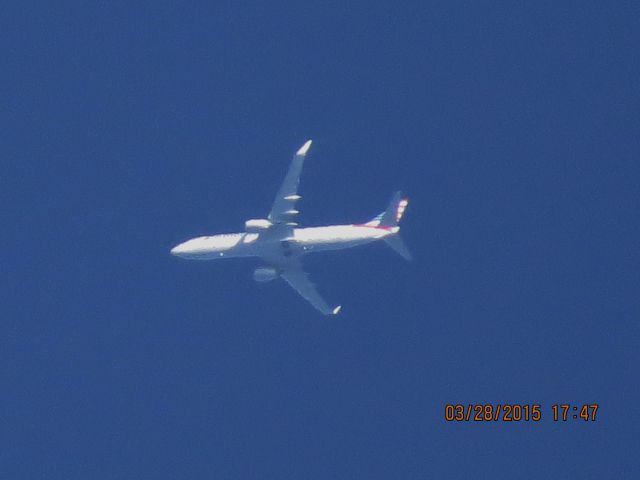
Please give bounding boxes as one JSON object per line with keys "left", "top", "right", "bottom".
{"left": 171, "top": 140, "right": 411, "bottom": 315}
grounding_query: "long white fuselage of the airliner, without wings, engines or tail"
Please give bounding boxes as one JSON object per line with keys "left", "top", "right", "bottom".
{"left": 171, "top": 225, "right": 399, "bottom": 264}
